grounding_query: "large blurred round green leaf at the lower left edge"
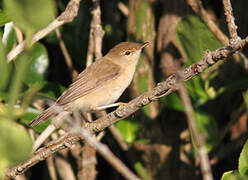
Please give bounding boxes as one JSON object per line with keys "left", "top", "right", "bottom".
{"left": 0, "top": 119, "right": 32, "bottom": 177}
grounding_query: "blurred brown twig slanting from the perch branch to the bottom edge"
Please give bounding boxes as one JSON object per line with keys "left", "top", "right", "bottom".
{"left": 178, "top": 75, "right": 213, "bottom": 180}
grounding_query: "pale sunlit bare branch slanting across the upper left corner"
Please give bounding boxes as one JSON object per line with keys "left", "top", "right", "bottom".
{"left": 7, "top": 0, "right": 81, "bottom": 62}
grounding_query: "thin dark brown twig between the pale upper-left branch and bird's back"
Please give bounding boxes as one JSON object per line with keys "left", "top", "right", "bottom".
{"left": 55, "top": 28, "right": 78, "bottom": 80}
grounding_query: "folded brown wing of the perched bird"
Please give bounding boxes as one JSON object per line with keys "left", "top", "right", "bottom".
{"left": 56, "top": 59, "right": 121, "bottom": 105}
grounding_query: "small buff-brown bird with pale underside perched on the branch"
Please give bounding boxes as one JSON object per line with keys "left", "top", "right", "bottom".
{"left": 29, "top": 42, "right": 149, "bottom": 126}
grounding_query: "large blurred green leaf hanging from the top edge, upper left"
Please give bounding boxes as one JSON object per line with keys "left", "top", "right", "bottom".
{"left": 4, "top": 0, "right": 55, "bottom": 42}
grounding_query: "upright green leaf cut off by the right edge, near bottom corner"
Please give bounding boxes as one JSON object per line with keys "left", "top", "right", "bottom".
{"left": 238, "top": 140, "right": 248, "bottom": 175}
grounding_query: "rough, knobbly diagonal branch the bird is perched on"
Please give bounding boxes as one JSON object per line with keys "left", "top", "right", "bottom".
{"left": 6, "top": 37, "right": 248, "bottom": 178}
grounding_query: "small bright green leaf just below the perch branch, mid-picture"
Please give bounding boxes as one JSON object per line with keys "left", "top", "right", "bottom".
{"left": 116, "top": 118, "right": 139, "bottom": 144}
